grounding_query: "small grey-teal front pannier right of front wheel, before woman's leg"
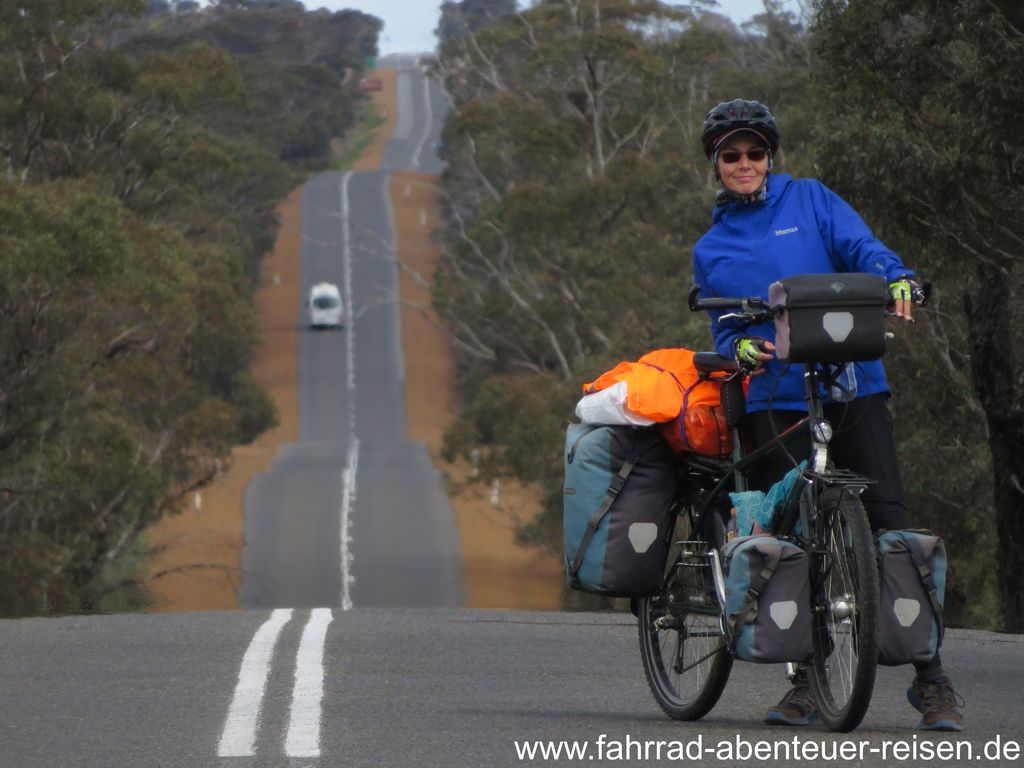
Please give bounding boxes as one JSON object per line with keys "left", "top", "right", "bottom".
{"left": 874, "top": 530, "right": 946, "bottom": 667}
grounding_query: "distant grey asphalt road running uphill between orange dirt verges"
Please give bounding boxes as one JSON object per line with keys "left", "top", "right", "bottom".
{"left": 240, "top": 58, "right": 465, "bottom": 608}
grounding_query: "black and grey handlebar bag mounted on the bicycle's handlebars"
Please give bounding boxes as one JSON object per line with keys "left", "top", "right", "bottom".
{"left": 768, "top": 272, "right": 889, "bottom": 362}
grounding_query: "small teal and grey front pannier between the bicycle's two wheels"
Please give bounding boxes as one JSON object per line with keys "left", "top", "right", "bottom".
{"left": 725, "top": 536, "right": 814, "bottom": 664}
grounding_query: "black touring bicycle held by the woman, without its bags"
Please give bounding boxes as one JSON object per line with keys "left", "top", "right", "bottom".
{"left": 636, "top": 280, "right": 892, "bottom": 732}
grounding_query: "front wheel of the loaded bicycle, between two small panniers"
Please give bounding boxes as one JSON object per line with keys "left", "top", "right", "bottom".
{"left": 808, "top": 488, "right": 879, "bottom": 733}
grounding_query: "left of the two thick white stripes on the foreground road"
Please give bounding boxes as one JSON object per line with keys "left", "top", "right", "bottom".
{"left": 217, "top": 608, "right": 292, "bottom": 758}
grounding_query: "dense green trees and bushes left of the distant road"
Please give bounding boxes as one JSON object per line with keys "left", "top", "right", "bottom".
{"left": 0, "top": 0, "right": 379, "bottom": 614}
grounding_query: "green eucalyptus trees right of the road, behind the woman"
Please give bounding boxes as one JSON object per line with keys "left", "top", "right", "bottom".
{"left": 435, "top": 0, "right": 1024, "bottom": 629}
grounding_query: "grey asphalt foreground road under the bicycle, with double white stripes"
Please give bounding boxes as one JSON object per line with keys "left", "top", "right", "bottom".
{"left": 0, "top": 607, "right": 1024, "bottom": 768}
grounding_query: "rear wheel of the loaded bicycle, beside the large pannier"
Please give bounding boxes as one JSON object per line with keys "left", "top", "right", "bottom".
{"left": 637, "top": 515, "right": 732, "bottom": 720}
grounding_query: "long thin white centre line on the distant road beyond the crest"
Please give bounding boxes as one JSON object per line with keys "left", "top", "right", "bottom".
{"left": 341, "top": 171, "right": 359, "bottom": 610}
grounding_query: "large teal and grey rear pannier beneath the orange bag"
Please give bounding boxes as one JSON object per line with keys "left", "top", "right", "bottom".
{"left": 562, "top": 424, "right": 676, "bottom": 597}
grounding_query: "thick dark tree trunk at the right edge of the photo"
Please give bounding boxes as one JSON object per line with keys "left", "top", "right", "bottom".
{"left": 954, "top": 262, "right": 1024, "bottom": 633}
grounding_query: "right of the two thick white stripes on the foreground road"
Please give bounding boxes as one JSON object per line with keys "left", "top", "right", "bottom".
{"left": 285, "top": 608, "right": 334, "bottom": 758}
